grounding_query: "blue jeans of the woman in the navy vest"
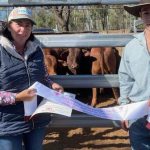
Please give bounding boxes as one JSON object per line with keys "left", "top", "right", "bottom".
{"left": 0, "top": 128, "right": 46, "bottom": 150}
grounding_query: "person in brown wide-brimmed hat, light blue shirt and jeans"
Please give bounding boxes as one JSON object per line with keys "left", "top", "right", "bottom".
{"left": 119, "top": 0, "right": 150, "bottom": 150}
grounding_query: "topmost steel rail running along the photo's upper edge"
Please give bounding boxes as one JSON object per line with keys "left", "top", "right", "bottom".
{"left": 0, "top": 0, "right": 139, "bottom": 7}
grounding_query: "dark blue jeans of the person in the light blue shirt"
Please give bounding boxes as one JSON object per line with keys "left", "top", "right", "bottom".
{"left": 129, "top": 117, "right": 150, "bottom": 150}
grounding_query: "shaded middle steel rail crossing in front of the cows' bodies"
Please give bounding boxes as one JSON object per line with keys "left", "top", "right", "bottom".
{"left": 51, "top": 74, "right": 119, "bottom": 88}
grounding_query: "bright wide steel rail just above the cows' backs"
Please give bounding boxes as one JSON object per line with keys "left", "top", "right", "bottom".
{"left": 36, "top": 33, "right": 133, "bottom": 48}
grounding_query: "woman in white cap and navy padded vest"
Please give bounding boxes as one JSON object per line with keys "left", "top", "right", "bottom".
{"left": 0, "top": 7, "right": 63, "bottom": 150}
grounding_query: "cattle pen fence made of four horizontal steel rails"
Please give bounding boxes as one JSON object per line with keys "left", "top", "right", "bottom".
{"left": 0, "top": 0, "right": 139, "bottom": 128}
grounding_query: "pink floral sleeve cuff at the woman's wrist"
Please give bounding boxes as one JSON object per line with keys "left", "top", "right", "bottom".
{"left": 0, "top": 91, "right": 16, "bottom": 106}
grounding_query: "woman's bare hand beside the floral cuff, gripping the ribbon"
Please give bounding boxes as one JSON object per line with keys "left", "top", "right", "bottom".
{"left": 15, "top": 89, "right": 36, "bottom": 101}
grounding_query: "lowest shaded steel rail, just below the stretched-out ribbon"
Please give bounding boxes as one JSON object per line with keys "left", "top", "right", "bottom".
{"left": 49, "top": 113, "right": 121, "bottom": 128}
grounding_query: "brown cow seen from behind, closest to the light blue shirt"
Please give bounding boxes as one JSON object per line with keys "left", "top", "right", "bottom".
{"left": 90, "top": 47, "right": 119, "bottom": 106}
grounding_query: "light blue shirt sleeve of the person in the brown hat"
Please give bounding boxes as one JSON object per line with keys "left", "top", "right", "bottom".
{"left": 118, "top": 47, "right": 134, "bottom": 105}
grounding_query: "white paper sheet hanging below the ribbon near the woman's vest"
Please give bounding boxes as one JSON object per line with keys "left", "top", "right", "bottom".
{"left": 31, "top": 99, "right": 72, "bottom": 117}
